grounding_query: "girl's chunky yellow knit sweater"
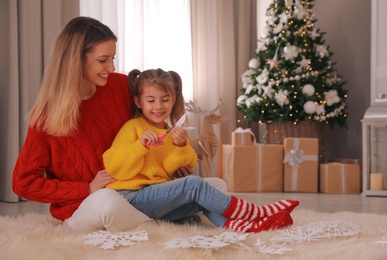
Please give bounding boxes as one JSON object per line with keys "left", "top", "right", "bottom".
{"left": 103, "top": 117, "right": 197, "bottom": 190}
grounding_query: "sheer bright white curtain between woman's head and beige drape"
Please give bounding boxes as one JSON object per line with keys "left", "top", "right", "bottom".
{"left": 80, "top": 0, "right": 193, "bottom": 99}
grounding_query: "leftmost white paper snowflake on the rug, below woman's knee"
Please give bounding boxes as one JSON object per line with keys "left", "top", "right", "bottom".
{"left": 85, "top": 230, "right": 148, "bottom": 250}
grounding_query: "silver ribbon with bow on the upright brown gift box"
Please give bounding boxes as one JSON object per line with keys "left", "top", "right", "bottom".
{"left": 284, "top": 138, "right": 318, "bottom": 191}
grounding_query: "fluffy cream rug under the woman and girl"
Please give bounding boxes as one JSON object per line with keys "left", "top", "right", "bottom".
{"left": 0, "top": 209, "right": 387, "bottom": 260}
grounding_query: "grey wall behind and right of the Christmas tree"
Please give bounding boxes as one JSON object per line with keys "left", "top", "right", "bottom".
{"left": 257, "top": 0, "right": 371, "bottom": 158}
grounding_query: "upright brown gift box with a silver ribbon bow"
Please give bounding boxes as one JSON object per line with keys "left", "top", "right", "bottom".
{"left": 284, "top": 138, "right": 319, "bottom": 192}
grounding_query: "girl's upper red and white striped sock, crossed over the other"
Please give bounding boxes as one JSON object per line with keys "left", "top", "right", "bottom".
{"left": 222, "top": 196, "right": 300, "bottom": 221}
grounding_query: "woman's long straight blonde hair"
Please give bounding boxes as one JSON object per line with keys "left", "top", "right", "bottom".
{"left": 28, "top": 17, "right": 117, "bottom": 136}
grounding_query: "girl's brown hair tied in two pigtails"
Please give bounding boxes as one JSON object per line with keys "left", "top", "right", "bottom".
{"left": 128, "top": 69, "right": 185, "bottom": 125}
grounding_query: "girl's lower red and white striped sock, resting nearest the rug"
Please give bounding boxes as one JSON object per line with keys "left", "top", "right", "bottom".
{"left": 224, "top": 210, "right": 293, "bottom": 233}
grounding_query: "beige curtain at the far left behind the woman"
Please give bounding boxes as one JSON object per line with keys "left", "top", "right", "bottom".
{"left": 0, "top": 0, "right": 79, "bottom": 202}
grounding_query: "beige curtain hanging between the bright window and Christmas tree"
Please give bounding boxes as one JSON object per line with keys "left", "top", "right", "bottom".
{"left": 191, "top": 0, "right": 257, "bottom": 176}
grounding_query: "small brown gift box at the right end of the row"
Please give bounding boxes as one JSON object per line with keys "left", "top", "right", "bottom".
{"left": 320, "top": 163, "right": 360, "bottom": 194}
